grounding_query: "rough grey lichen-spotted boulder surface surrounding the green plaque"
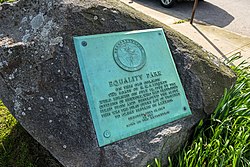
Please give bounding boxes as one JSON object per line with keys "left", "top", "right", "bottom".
{"left": 0, "top": 0, "right": 235, "bottom": 167}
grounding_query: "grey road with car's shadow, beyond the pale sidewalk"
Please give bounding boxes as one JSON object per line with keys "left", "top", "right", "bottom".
{"left": 130, "top": 0, "right": 250, "bottom": 37}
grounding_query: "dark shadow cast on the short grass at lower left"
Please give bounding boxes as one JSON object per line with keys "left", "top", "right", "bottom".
{"left": 0, "top": 123, "right": 62, "bottom": 167}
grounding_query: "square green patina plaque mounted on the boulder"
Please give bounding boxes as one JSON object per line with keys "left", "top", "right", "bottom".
{"left": 74, "top": 28, "right": 191, "bottom": 146}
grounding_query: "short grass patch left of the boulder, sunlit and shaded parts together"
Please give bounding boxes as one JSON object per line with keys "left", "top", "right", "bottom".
{"left": 0, "top": 101, "right": 62, "bottom": 167}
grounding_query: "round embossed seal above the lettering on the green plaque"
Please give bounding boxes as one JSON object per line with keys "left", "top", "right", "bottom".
{"left": 113, "top": 39, "right": 146, "bottom": 71}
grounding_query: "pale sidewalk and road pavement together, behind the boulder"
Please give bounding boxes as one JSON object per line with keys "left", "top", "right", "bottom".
{"left": 121, "top": 0, "right": 250, "bottom": 64}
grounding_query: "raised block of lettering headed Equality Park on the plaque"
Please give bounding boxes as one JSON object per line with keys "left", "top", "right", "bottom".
{"left": 99, "top": 71, "right": 180, "bottom": 127}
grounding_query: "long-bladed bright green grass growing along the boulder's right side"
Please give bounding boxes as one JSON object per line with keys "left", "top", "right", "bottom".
{"left": 148, "top": 59, "right": 250, "bottom": 167}
